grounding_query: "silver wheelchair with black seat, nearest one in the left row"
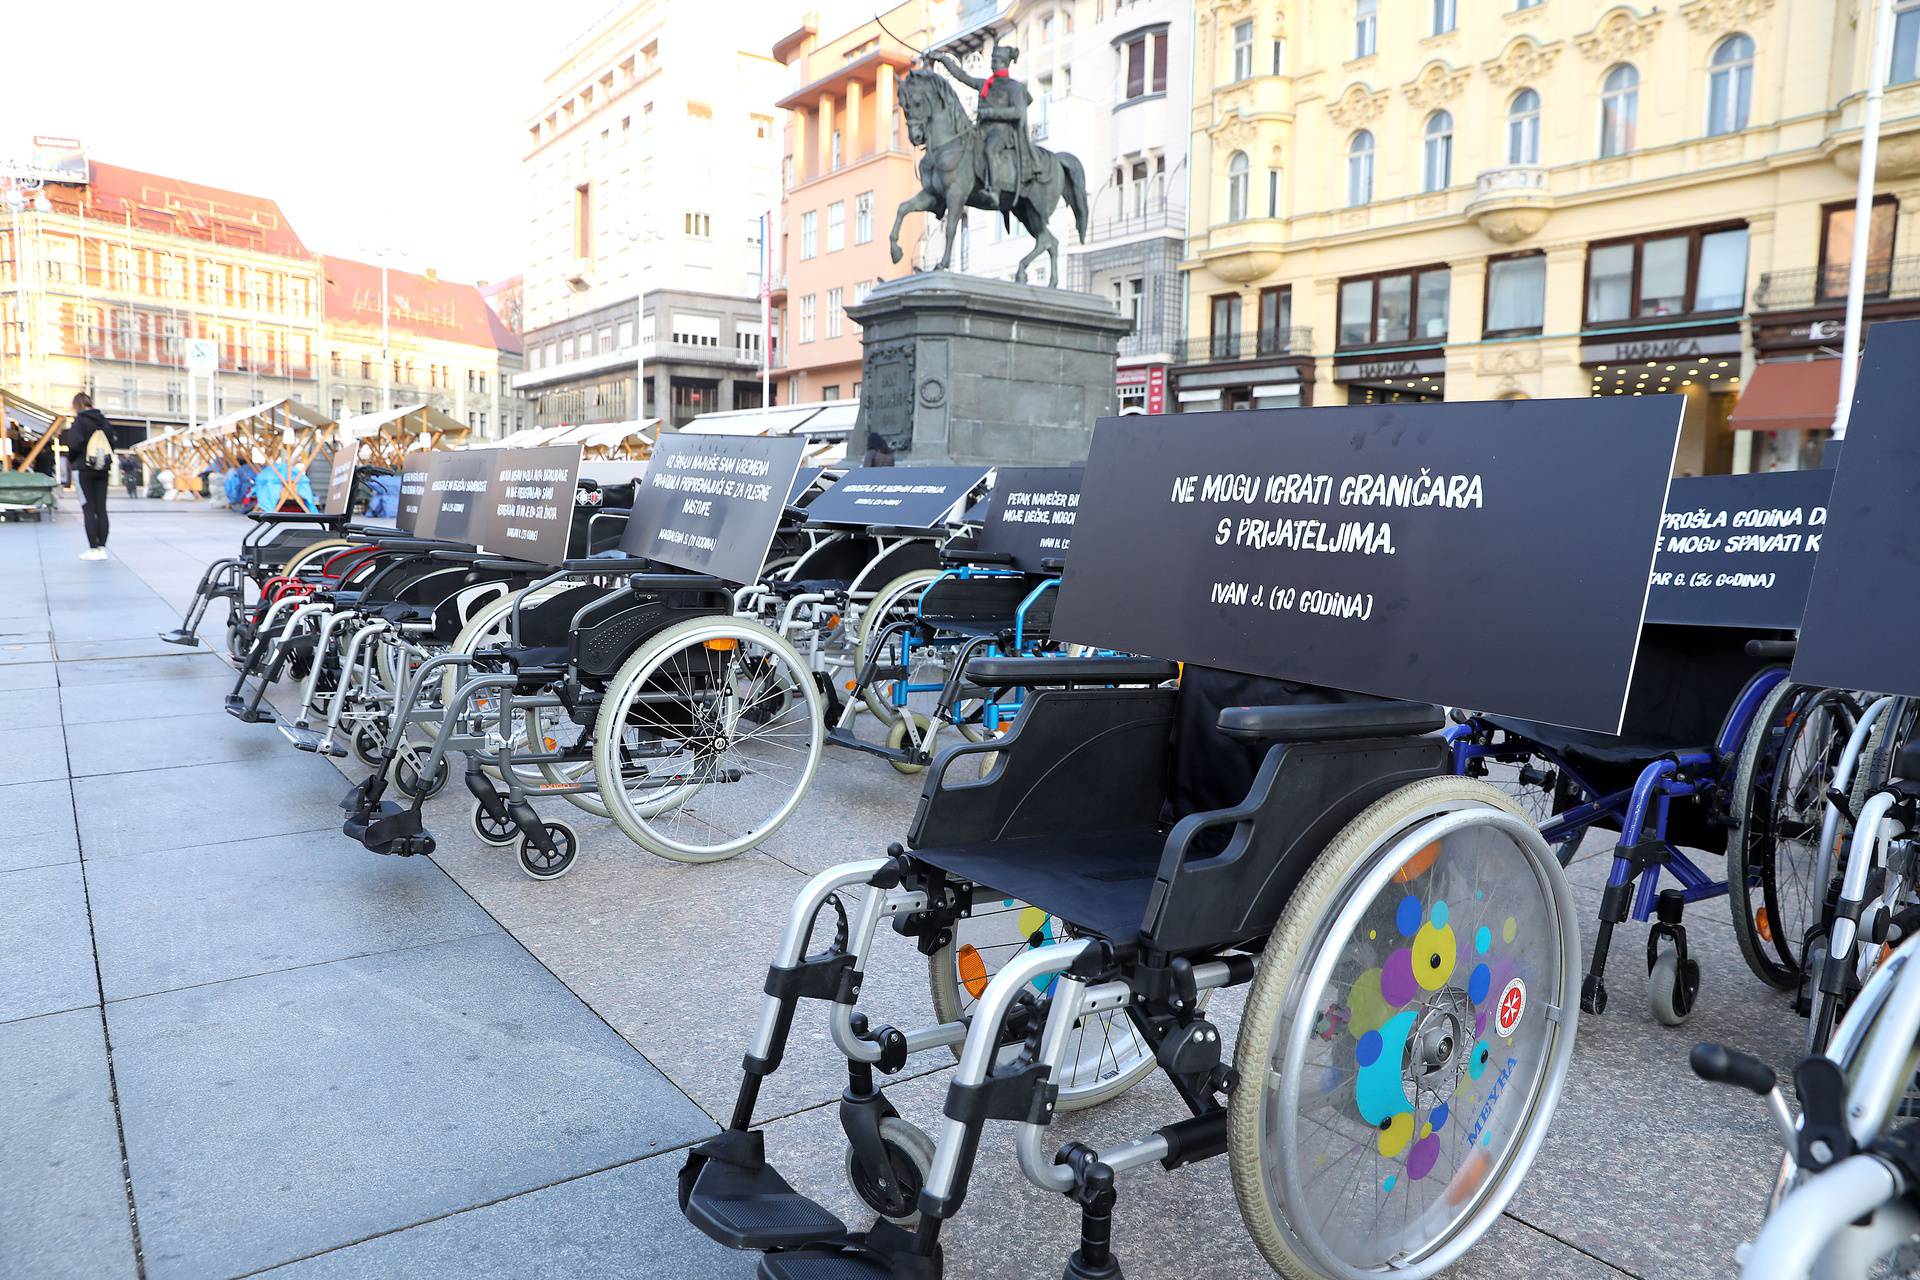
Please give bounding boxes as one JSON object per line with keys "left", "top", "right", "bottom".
{"left": 342, "top": 537, "right": 824, "bottom": 879}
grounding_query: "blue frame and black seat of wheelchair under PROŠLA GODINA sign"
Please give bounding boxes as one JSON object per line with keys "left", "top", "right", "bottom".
{"left": 1448, "top": 624, "right": 1834, "bottom": 1027}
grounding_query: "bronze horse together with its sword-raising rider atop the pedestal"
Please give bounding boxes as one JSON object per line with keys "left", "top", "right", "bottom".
{"left": 889, "top": 44, "right": 1087, "bottom": 284}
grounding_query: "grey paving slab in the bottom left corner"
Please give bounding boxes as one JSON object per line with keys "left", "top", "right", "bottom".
{"left": 0, "top": 1013, "right": 136, "bottom": 1280}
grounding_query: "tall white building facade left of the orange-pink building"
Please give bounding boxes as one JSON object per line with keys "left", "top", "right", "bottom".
{"left": 516, "top": 0, "right": 791, "bottom": 426}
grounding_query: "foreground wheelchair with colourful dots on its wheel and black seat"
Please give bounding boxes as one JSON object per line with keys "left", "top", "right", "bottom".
{"left": 680, "top": 656, "right": 1580, "bottom": 1280}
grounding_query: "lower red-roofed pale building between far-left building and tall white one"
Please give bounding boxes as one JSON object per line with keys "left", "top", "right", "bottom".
{"left": 319, "top": 257, "right": 528, "bottom": 439}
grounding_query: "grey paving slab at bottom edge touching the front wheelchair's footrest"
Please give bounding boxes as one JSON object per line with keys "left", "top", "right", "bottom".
{"left": 249, "top": 1155, "right": 741, "bottom": 1280}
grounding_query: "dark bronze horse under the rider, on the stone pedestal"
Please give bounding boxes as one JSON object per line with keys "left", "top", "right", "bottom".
{"left": 889, "top": 69, "right": 1087, "bottom": 284}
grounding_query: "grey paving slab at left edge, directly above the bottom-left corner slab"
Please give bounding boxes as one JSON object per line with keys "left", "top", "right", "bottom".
{"left": 0, "top": 862, "right": 100, "bottom": 1028}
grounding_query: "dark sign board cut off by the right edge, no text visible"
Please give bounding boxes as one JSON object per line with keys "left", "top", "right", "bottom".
{"left": 1793, "top": 320, "right": 1920, "bottom": 697}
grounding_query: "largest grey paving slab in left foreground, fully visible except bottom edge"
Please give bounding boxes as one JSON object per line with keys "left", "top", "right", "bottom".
{"left": 108, "top": 935, "right": 712, "bottom": 1280}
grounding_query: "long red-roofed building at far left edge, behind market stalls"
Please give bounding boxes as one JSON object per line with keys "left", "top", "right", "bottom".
{"left": 0, "top": 161, "right": 321, "bottom": 428}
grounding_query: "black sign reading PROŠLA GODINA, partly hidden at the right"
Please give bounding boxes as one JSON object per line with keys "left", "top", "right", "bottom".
{"left": 1647, "top": 470, "right": 1834, "bottom": 631}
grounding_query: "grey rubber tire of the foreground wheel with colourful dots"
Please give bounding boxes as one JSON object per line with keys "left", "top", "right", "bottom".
{"left": 1227, "top": 777, "right": 1580, "bottom": 1280}
